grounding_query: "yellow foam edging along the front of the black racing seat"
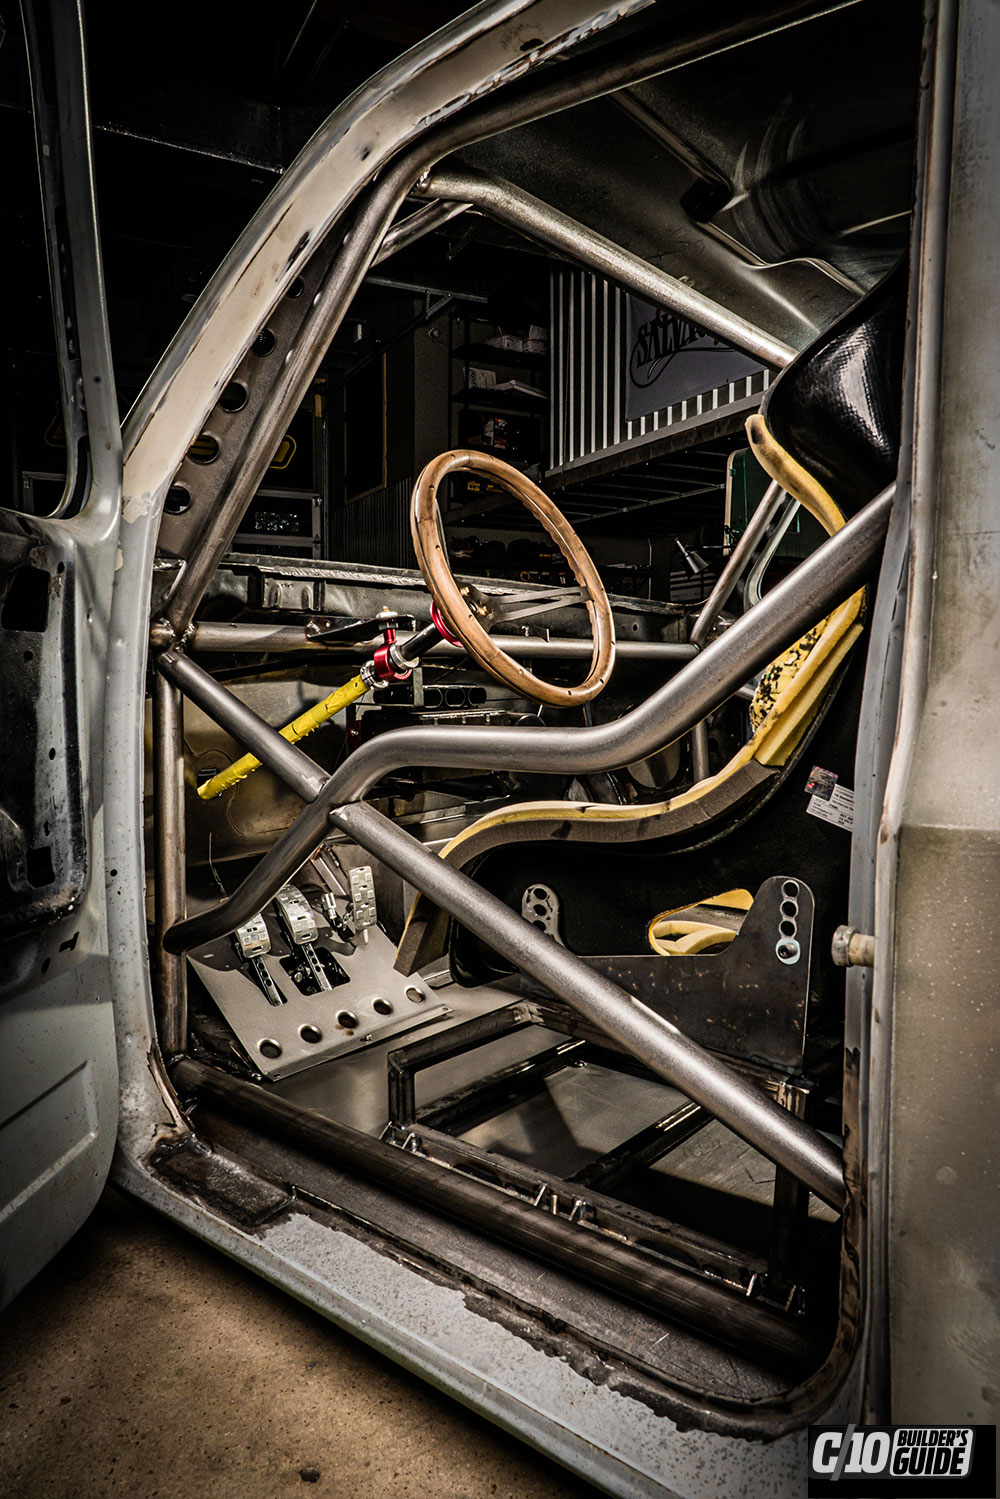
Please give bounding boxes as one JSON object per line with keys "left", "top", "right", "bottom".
{"left": 400, "top": 414, "right": 865, "bottom": 947}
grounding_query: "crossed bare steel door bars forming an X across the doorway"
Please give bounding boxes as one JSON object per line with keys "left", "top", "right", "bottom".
{"left": 159, "top": 486, "right": 895, "bottom": 1208}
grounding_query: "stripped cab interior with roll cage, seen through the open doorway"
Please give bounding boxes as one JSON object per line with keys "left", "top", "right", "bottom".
{"left": 7, "top": 4, "right": 921, "bottom": 1430}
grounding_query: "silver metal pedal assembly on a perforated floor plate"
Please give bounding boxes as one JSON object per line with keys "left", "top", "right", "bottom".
{"left": 189, "top": 850, "right": 451, "bottom": 1079}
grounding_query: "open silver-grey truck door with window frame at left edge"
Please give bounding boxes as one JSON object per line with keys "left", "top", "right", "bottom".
{"left": 0, "top": 0, "right": 121, "bottom": 1304}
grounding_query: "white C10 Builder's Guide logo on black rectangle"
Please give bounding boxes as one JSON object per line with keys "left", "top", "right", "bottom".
{"left": 808, "top": 1426, "right": 997, "bottom": 1499}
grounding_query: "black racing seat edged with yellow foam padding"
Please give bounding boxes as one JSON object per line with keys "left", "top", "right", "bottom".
{"left": 396, "top": 265, "right": 907, "bottom": 1001}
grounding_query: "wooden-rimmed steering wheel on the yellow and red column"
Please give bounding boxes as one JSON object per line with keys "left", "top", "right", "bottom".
{"left": 409, "top": 448, "right": 615, "bottom": 708}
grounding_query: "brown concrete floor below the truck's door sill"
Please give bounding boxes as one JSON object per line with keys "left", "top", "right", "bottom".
{"left": 0, "top": 1192, "right": 597, "bottom": 1499}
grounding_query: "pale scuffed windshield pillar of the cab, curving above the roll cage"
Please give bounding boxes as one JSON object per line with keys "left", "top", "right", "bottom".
{"left": 124, "top": 0, "right": 656, "bottom": 508}
